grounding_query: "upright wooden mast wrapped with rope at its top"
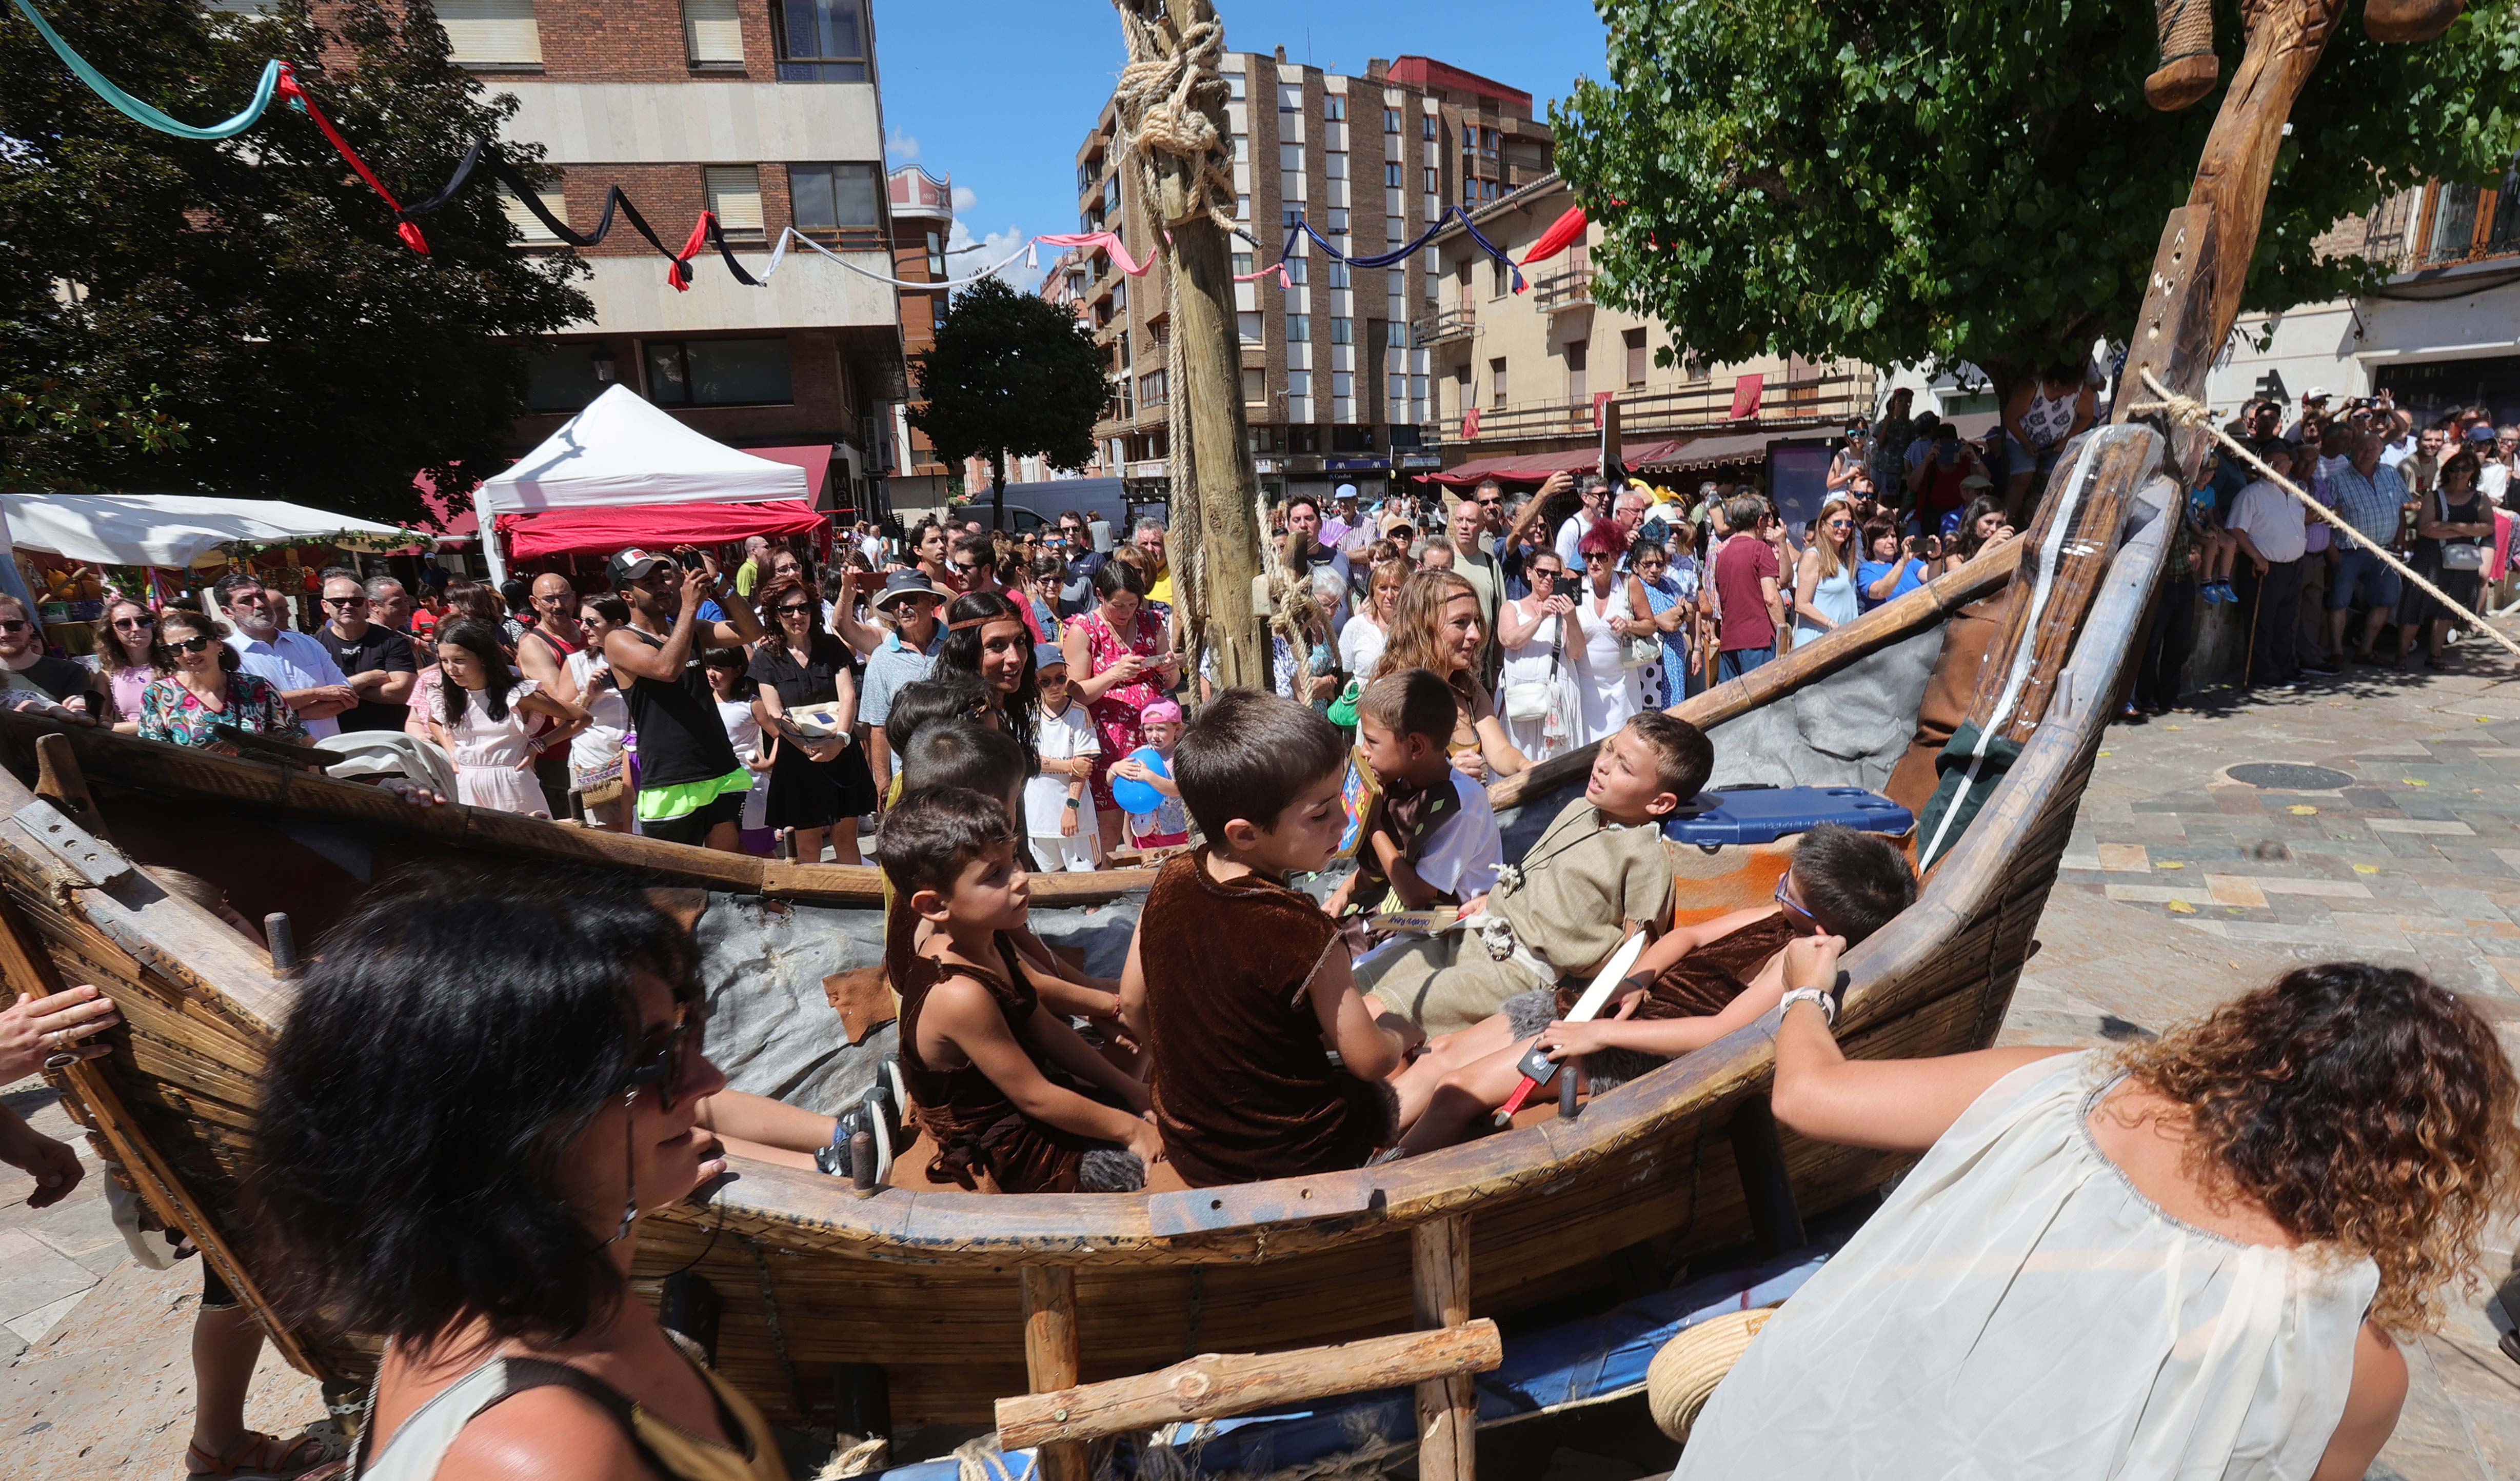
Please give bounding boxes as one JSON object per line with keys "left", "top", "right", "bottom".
{"left": 1121, "top": 0, "right": 1270, "bottom": 690}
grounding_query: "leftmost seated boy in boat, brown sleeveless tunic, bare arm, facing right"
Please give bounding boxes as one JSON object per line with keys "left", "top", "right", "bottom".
{"left": 875, "top": 786, "right": 1162, "bottom": 1194}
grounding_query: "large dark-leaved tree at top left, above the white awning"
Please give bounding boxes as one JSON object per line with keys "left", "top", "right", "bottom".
{"left": 0, "top": 0, "right": 590, "bottom": 521}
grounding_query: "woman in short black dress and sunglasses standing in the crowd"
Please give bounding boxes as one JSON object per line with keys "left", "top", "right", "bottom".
{"left": 748, "top": 572, "right": 875, "bottom": 864}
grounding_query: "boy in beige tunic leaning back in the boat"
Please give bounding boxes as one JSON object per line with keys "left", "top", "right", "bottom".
{"left": 1356, "top": 710, "right": 1716, "bottom": 1033}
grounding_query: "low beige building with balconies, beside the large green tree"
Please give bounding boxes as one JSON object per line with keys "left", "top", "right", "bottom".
{"left": 1411, "top": 174, "right": 1880, "bottom": 501}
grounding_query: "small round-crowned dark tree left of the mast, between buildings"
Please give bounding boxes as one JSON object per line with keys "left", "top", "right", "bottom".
{"left": 910, "top": 277, "right": 1112, "bottom": 526}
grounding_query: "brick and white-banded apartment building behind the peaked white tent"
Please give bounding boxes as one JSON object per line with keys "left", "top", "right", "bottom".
{"left": 436, "top": 0, "right": 905, "bottom": 514}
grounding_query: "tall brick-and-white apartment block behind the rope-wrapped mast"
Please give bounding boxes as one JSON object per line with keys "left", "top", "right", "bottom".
{"left": 1058, "top": 48, "right": 1555, "bottom": 499}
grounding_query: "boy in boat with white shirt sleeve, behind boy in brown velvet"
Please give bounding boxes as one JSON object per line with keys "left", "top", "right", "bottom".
{"left": 1323, "top": 667, "right": 1504, "bottom": 919}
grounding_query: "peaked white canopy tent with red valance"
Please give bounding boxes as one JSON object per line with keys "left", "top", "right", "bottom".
{"left": 474, "top": 385, "right": 822, "bottom": 582}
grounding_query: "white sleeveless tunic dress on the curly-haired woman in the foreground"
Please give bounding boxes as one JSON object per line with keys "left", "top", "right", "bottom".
{"left": 1673, "top": 1055, "right": 2379, "bottom": 1481}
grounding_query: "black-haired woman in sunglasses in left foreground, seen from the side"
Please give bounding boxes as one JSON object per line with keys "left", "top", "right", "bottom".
{"left": 254, "top": 872, "right": 801, "bottom": 1481}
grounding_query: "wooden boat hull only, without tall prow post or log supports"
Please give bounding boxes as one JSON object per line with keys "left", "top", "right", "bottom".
{"left": 0, "top": 476, "right": 2159, "bottom": 1423}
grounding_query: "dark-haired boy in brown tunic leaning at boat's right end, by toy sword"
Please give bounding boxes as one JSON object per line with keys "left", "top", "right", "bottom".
{"left": 1396, "top": 824, "right": 1915, "bottom": 1154}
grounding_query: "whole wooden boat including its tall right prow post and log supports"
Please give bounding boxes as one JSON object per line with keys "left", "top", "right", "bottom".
{"left": 0, "top": 0, "right": 2378, "bottom": 1481}
